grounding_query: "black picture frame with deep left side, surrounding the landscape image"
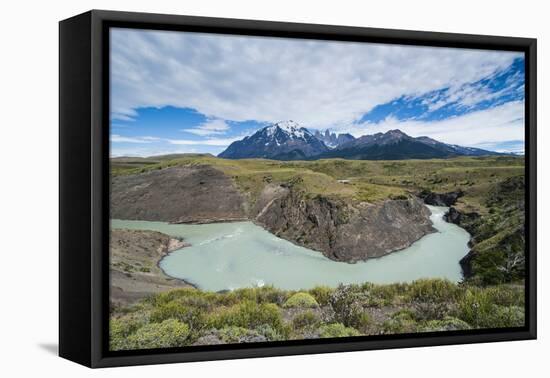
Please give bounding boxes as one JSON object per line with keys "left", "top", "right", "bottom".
{"left": 59, "top": 10, "right": 537, "bottom": 368}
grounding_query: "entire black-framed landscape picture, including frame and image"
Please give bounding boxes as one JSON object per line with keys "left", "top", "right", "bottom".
{"left": 59, "top": 11, "right": 536, "bottom": 367}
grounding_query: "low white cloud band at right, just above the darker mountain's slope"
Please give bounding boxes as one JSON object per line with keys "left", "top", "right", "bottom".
{"left": 339, "top": 101, "right": 525, "bottom": 148}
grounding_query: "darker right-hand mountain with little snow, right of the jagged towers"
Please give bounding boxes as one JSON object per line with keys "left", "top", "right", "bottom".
{"left": 319, "top": 130, "right": 499, "bottom": 160}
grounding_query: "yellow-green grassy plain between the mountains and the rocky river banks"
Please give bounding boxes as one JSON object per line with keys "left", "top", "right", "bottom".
{"left": 111, "top": 154, "right": 524, "bottom": 214}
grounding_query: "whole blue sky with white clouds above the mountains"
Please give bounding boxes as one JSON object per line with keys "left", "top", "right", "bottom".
{"left": 110, "top": 28, "right": 525, "bottom": 156}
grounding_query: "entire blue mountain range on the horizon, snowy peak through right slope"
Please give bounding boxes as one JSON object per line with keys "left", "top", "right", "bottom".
{"left": 218, "top": 121, "right": 501, "bottom": 160}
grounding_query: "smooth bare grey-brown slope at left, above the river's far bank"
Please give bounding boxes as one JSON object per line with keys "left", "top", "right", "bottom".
{"left": 111, "top": 165, "right": 247, "bottom": 223}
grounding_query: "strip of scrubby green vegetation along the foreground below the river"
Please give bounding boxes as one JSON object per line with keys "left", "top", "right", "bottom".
{"left": 110, "top": 279, "right": 524, "bottom": 350}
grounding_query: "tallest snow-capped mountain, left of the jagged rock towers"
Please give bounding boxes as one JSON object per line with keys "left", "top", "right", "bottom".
{"left": 218, "top": 121, "right": 328, "bottom": 160}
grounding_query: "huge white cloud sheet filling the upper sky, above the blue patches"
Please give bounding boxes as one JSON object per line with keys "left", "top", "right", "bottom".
{"left": 111, "top": 29, "right": 519, "bottom": 129}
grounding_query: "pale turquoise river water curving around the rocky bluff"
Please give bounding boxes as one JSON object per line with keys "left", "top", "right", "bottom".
{"left": 111, "top": 206, "right": 470, "bottom": 291}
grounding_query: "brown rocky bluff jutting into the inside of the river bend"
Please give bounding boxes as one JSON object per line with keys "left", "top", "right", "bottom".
{"left": 256, "top": 188, "right": 435, "bottom": 262}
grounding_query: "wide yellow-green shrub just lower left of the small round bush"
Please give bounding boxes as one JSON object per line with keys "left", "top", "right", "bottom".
{"left": 208, "top": 300, "right": 285, "bottom": 332}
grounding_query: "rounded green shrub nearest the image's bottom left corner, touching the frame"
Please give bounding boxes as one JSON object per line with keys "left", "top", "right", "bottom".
{"left": 124, "top": 319, "right": 190, "bottom": 349}
